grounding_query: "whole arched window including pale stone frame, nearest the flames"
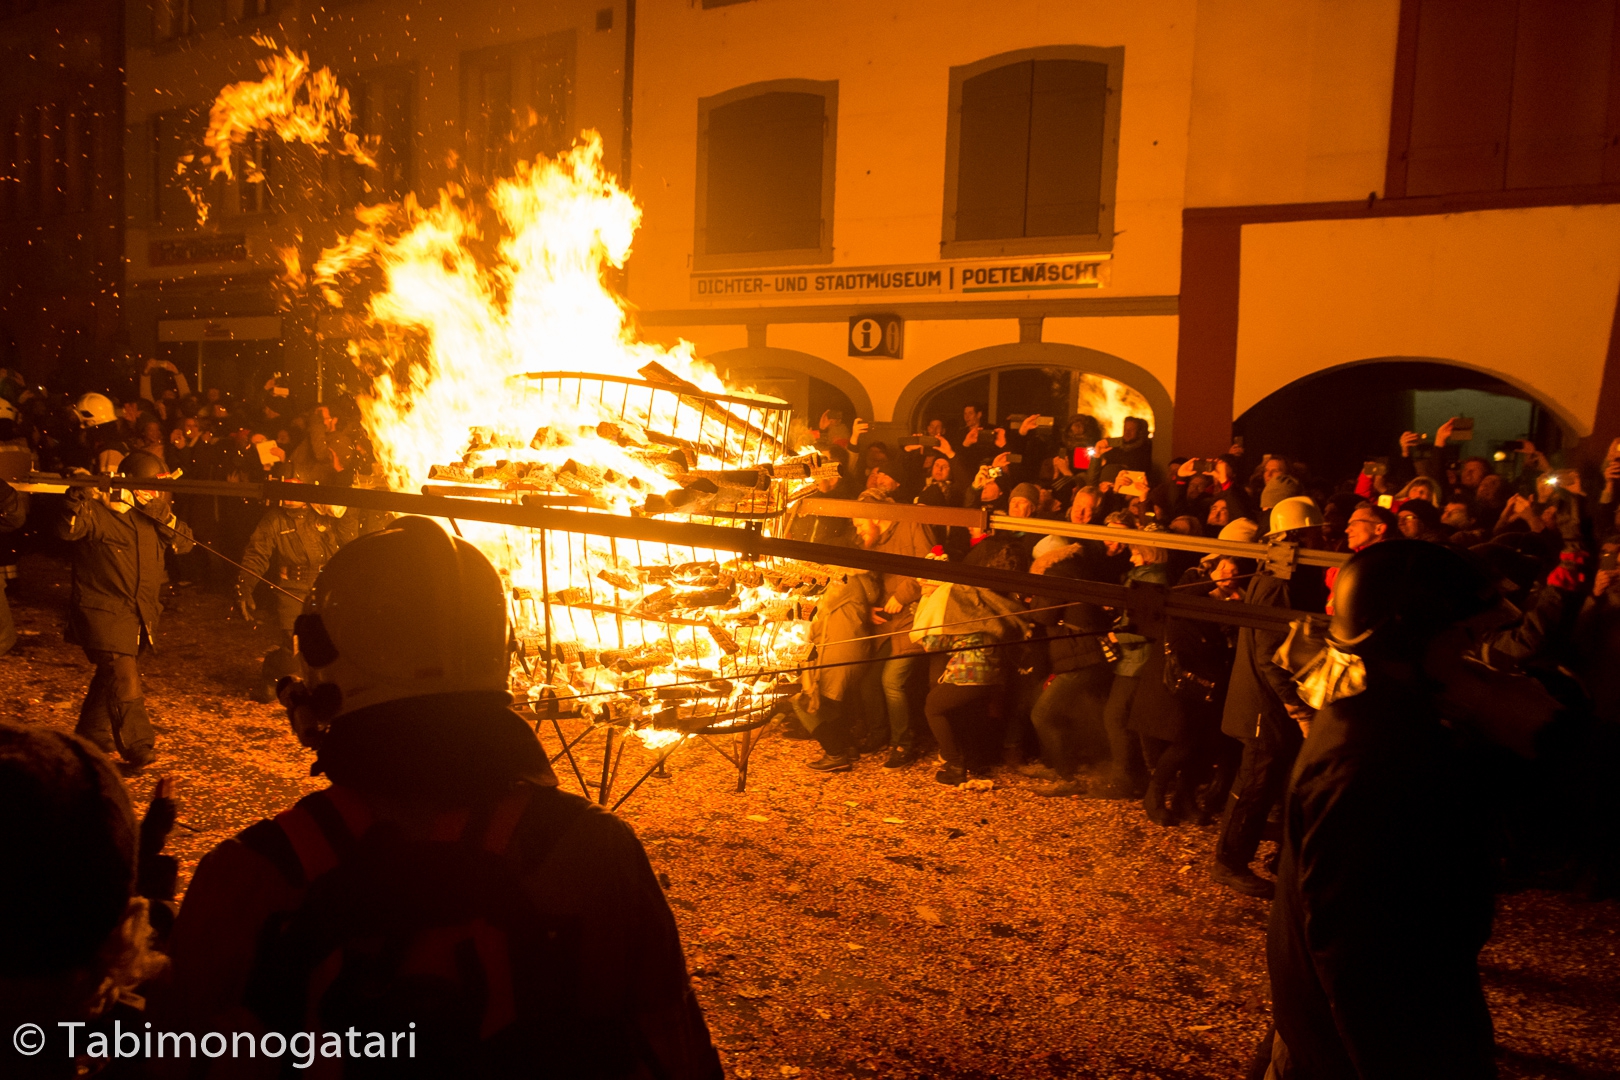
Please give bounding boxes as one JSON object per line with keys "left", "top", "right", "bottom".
{"left": 693, "top": 79, "right": 838, "bottom": 270}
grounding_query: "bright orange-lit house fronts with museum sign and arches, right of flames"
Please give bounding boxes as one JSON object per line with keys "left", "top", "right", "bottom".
{"left": 632, "top": 0, "right": 1620, "bottom": 472}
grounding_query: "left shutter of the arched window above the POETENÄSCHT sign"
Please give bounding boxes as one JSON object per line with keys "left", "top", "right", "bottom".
{"left": 956, "top": 60, "right": 1035, "bottom": 240}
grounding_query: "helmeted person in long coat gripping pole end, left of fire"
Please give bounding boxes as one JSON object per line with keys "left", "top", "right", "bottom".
{"left": 58, "top": 452, "right": 193, "bottom": 771}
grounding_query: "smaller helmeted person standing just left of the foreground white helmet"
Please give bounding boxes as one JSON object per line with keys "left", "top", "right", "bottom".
{"left": 237, "top": 466, "right": 356, "bottom": 703}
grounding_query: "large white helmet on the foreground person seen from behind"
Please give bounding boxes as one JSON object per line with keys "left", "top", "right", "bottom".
{"left": 280, "top": 517, "right": 510, "bottom": 733}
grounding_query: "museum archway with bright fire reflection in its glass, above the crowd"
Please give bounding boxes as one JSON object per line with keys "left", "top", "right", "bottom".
{"left": 894, "top": 342, "right": 1175, "bottom": 468}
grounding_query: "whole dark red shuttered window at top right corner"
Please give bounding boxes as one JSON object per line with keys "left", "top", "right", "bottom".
{"left": 1385, "top": 0, "right": 1620, "bottom": 198}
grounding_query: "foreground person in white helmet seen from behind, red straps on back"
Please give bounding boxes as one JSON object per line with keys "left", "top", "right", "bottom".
{"left": 154, "top": 517, "right": 723, "bottom": 1080}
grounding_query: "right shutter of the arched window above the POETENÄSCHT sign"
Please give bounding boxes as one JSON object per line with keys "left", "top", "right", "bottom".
{"left": 1024, "top": 60, "right": 1108, "bottom": 236}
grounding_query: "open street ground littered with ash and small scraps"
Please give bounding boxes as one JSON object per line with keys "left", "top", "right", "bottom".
{"left": 0, "top": 557, "right": 1620, "bottom": 1080}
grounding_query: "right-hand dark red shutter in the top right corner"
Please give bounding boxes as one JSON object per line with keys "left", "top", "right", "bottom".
{"left": 1507, "top": 0, "right": 1615, "bottom": 188}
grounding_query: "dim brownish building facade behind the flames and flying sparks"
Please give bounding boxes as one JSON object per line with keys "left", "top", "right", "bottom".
{"left": 123, "top": 0, "right": 625, "bottom": 400}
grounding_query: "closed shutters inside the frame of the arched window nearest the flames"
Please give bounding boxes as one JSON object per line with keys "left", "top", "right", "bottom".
{"left": 703, "top": 91, "right": 826, "bottom": 254}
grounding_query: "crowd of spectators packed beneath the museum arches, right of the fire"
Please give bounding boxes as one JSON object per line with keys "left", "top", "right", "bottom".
{"left": 791, "top": 405, "right": 1620, "bottom": 895}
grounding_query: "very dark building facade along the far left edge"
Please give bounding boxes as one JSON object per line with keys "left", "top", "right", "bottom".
{"left": 0, "top": 0, "right": 123, "bottom": 385}
